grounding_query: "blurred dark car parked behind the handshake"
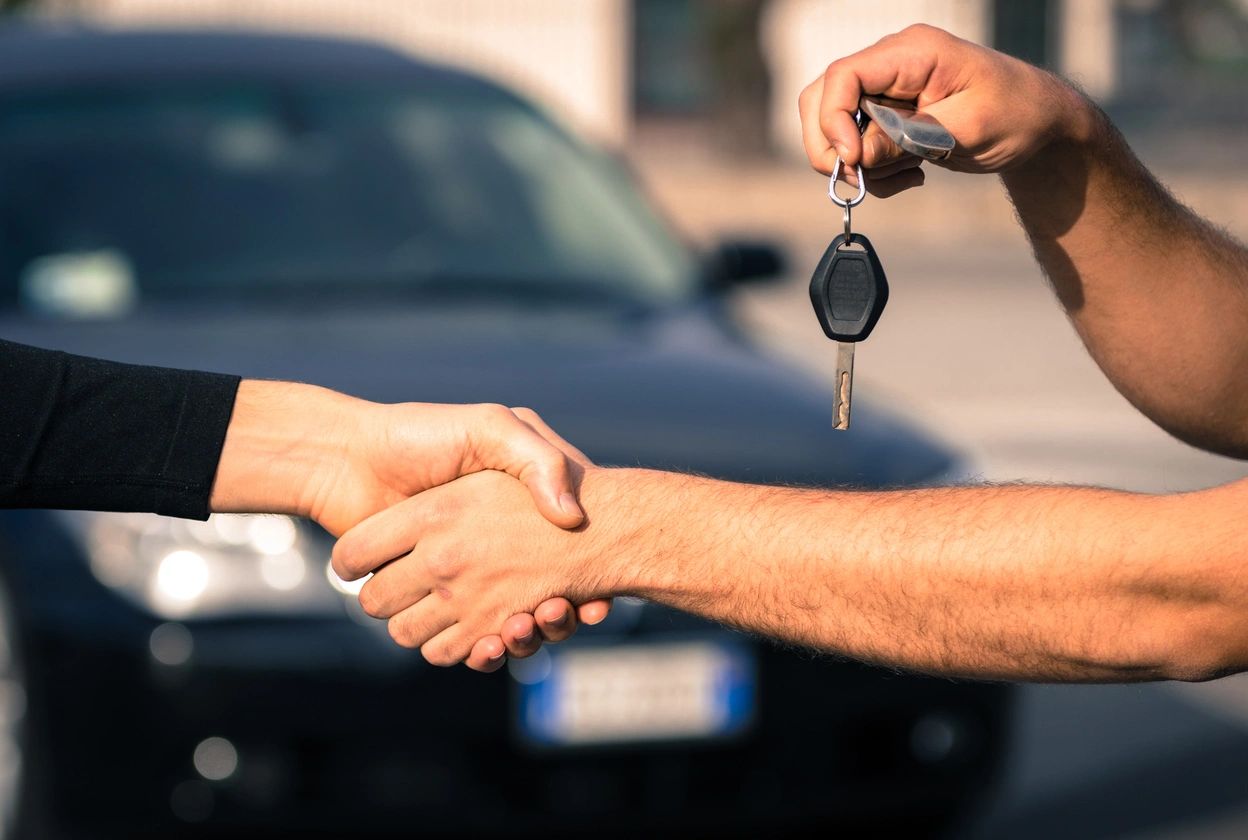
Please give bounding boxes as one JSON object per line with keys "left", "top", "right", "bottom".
{"left": 0, "top": 27, "right": 1008, "bottom": 836}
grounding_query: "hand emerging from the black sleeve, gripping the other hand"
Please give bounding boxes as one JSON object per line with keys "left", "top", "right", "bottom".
{"left": 211, "top": 381, "right": 610, "bottom": 629}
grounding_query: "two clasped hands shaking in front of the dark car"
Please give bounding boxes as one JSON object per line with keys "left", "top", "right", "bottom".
{"left": 218, "top": 381, "right": 623, "bottom": 672}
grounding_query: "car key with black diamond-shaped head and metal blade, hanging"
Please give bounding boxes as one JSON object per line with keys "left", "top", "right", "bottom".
{"left": 810, "top": 233, "right": 889, "bottom": 431}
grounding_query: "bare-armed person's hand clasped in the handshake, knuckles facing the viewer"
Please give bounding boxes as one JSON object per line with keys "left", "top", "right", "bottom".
{"left": 333, "top": 468, "right": 628, "bottom": 670}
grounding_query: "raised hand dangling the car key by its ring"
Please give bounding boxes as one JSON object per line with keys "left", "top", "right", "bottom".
{"left": 797, "top": 24, "right": 1087, "bottom": 196}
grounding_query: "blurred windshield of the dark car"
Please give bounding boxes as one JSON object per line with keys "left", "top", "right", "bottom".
{"left": 0, "top": 84, "right": 696, "bottom": 310}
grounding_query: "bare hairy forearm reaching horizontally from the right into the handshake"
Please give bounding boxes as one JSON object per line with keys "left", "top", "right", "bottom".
{"left": 583, "top": 471, "right": 1248, "bottom": 681}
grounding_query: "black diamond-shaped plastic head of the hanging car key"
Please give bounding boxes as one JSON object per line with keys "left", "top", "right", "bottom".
{"left": 810, "top": 233, "right": 889, "bottom": 342}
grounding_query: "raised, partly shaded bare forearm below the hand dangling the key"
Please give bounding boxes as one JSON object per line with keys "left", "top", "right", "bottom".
{"left": 1002, "top": 81, "right": 1248, "bottom": 457}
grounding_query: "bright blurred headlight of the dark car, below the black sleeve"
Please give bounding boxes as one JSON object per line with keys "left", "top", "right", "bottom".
{"left": 60, "top": 510, "right": 363, "bottom": 620}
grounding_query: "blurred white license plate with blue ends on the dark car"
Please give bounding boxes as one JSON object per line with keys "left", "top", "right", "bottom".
{"left": 512, "top": 642, "right": 755, "bottom": 746}
